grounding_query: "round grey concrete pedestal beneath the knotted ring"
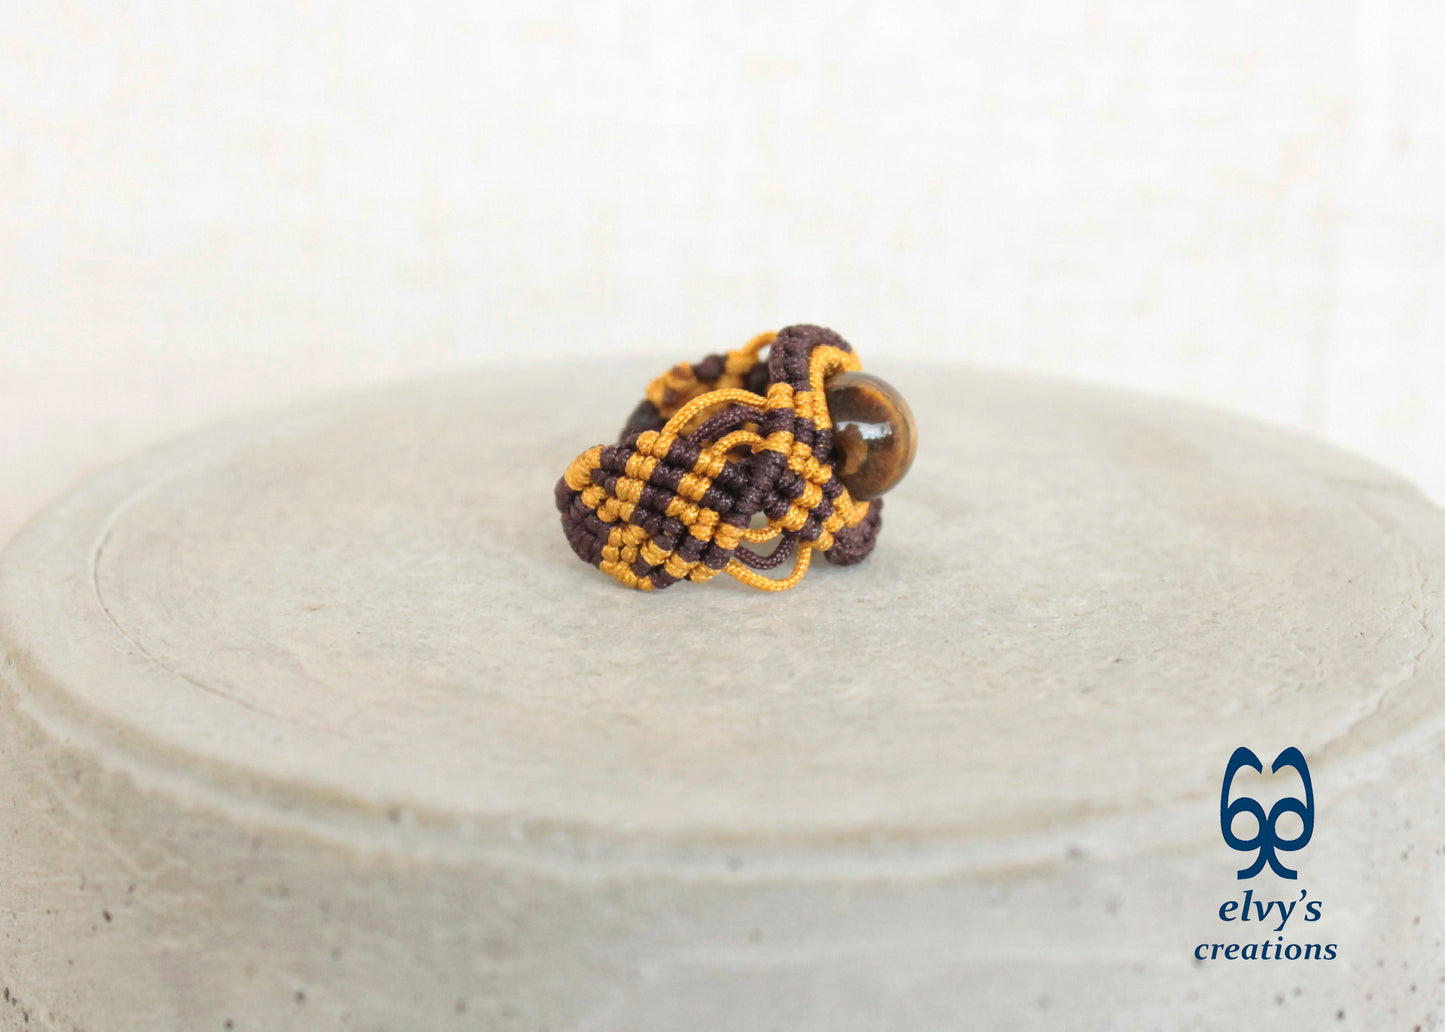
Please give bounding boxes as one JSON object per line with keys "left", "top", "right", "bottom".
{"left": 0, "top": 366, "right": 1445, "bottom": 1032}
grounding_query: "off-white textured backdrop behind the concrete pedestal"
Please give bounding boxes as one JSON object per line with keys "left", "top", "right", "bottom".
{"left": 0, "top": 0, "right": 1445, "bottom": 539}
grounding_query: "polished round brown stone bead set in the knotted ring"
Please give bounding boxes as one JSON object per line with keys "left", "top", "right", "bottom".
{"left": 824, "top": 373, "right": 918, "bottom": 502}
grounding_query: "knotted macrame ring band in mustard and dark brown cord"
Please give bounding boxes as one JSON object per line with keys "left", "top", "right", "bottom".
{"left": 556, "top": 325, "right": 912, "bottom": 591}
